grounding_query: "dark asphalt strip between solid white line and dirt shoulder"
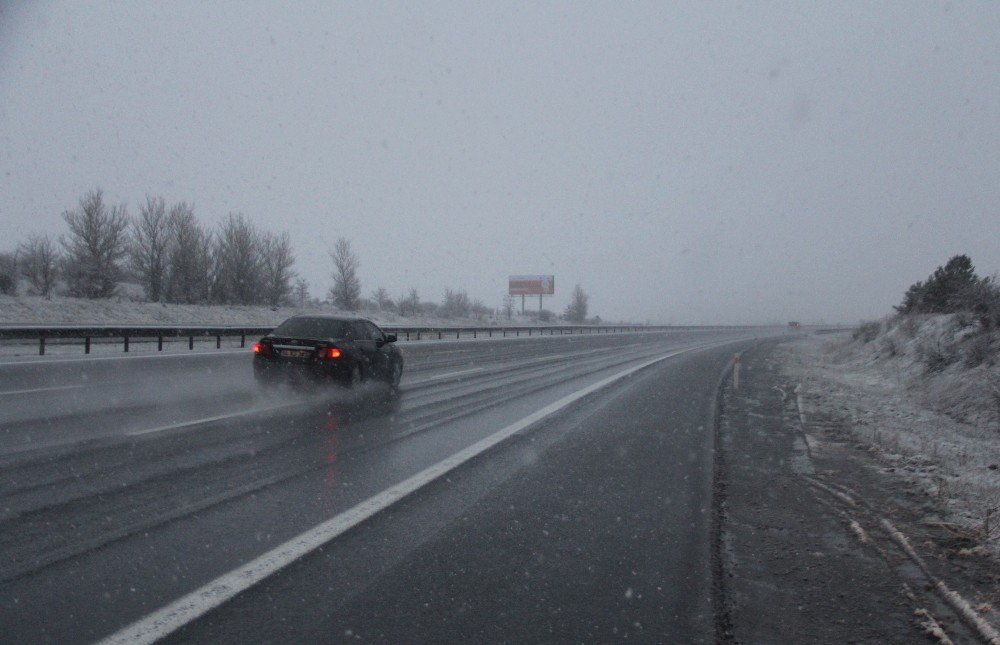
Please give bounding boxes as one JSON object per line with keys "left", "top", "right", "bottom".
{"left": 171, "top": 348, "right": 730, "bottom": 643}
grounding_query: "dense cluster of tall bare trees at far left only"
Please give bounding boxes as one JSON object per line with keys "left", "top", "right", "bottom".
{"left": 0, "top": 189, "right": 295, "bottom": 306}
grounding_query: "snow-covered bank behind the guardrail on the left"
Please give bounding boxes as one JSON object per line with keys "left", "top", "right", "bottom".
{"left": 0, "top": 295, "right": 498, "bottom": 327}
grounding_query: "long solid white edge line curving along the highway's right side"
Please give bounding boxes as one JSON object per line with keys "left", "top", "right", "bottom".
{"left": 99, "top": 346, "right": 705, "bottom": 645}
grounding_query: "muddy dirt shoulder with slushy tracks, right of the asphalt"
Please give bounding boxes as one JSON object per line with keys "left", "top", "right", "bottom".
{"left": 716, "top": 339, "right": 1000, "bottom": 643}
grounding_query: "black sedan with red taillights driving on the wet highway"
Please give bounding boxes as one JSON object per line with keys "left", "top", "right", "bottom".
{"left": 253, "top": 316, "right": 403, "bottom": 390}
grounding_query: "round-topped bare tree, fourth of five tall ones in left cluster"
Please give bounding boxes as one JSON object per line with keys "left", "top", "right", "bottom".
{"left": 212, "top": 213, "right": 264, "bottom": 305}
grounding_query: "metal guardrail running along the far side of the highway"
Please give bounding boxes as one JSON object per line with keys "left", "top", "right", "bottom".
{"left": 0, "top": 325, "right": 679, "bottom": 356}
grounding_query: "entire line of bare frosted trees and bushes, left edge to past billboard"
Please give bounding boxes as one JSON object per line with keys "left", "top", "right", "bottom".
{"left": 0, "top": 189, "right": 587, "bottom": 322}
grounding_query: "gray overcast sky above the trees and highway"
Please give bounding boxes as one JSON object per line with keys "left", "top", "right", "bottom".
{"left": 0, "top": 1, "right": 1000, "bottom": 323}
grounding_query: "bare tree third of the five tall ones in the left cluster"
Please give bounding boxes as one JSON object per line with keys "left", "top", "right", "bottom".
{"left": 166, "top": 202, "right": 212, "bottom": 304}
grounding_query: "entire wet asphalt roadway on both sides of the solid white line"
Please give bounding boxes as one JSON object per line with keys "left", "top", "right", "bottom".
{"left": 0, "top": 330, "right": 765, "bottom": 642}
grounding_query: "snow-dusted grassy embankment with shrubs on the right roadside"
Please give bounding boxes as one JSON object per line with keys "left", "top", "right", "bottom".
{"left": 783, "top": 314, "right": 1000, "bottom": 554}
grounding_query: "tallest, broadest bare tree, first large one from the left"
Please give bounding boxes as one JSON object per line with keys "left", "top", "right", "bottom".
{"left": 60, "top": 189, "right": 128, "bottom": 298}
